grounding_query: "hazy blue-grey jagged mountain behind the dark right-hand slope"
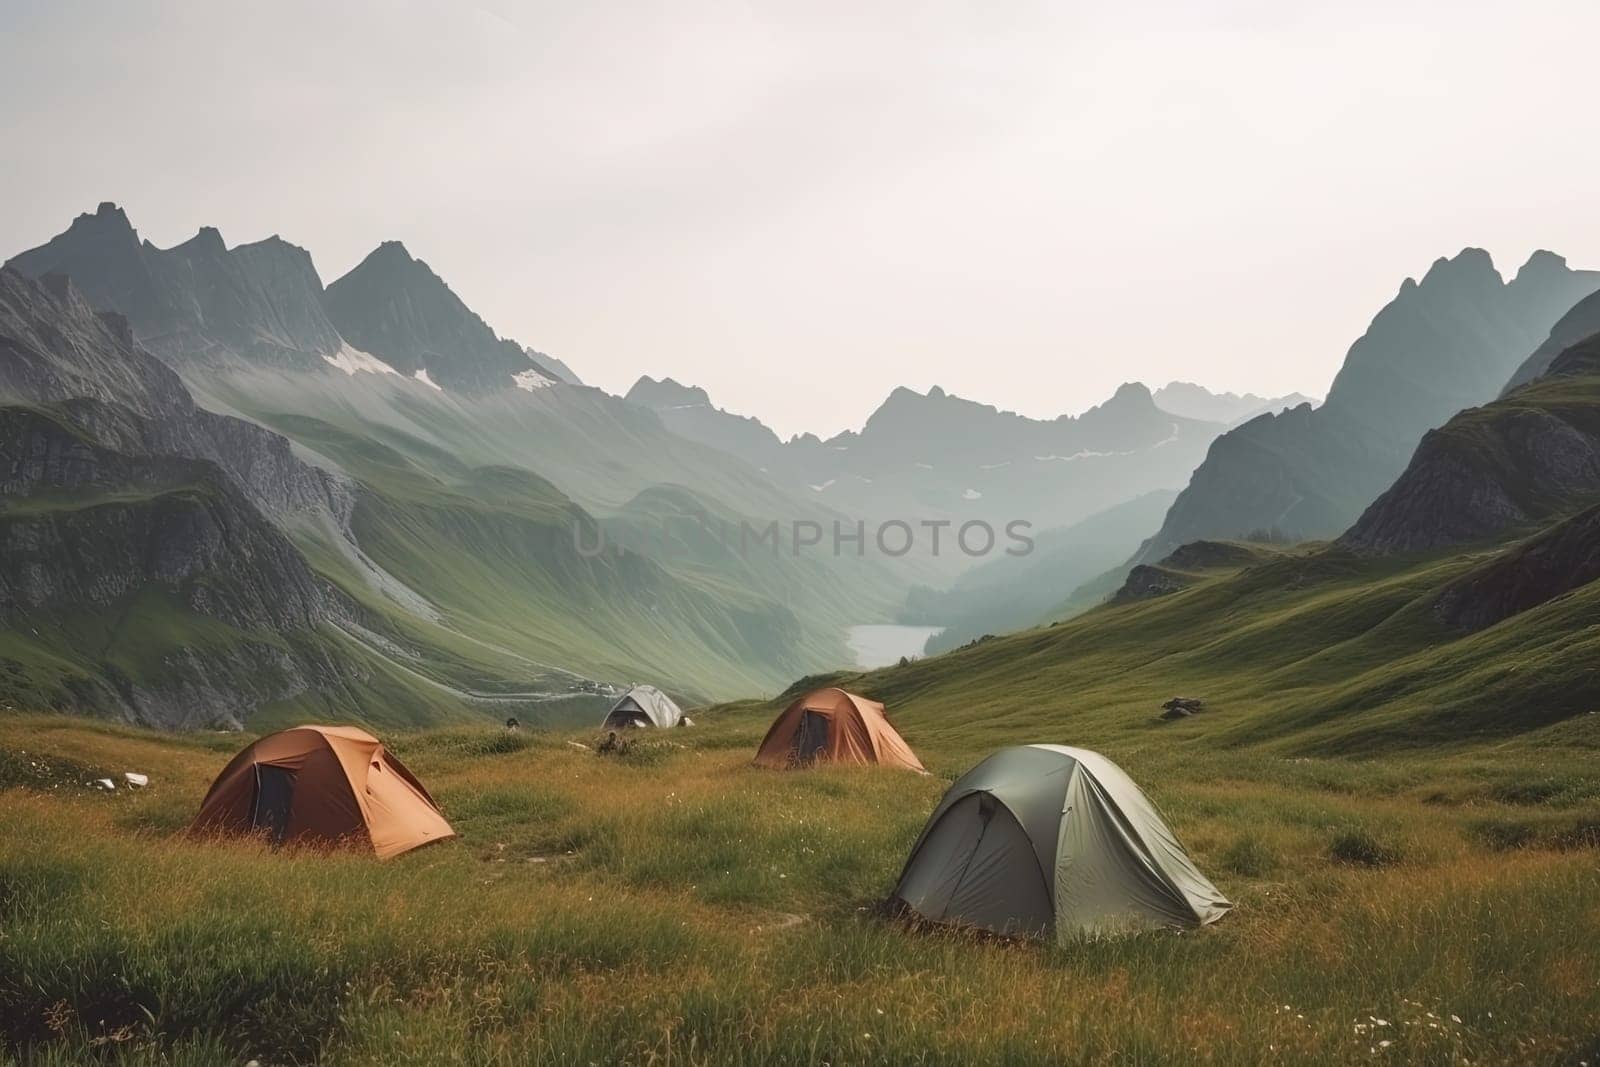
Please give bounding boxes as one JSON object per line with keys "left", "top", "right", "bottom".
{"left": 1139, "top": 248, "right": 1600, "bottom": 561}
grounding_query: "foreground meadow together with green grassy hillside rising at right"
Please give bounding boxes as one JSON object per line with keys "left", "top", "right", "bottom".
{"left": 0, "top": 531, "right": 1600, "bottom": 1064}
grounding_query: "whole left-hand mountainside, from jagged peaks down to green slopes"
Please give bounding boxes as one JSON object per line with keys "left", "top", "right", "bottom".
{"left": 0, "top": 205, "right": 928, "bottom": 725}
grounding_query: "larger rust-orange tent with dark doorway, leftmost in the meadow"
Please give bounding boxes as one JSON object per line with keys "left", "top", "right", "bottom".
{"left": 192, "top": 726, "right": 456, "bottom": 859}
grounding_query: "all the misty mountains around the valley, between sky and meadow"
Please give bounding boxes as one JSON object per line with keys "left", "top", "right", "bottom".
{"left": 9, "top": 203, "right": 1600, "bottom": 725}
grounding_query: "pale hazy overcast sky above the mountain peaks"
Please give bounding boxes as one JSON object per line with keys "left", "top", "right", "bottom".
{"left": 0, "top": 0, "right": 1600, "bottom": 434}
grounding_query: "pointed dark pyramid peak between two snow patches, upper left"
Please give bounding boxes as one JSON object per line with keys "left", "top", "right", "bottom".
{"left": 323, "top": 242, "right": 555, "bottom": 392}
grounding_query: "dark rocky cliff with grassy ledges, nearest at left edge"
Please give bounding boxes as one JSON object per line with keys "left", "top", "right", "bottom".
{"left": 0, "top": 269, "right": 374, "bottom": 726}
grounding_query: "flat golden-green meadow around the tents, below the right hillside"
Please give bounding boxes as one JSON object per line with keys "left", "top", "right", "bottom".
{"left": 0, "top": 705, "right": 1600, "bottom": 1064}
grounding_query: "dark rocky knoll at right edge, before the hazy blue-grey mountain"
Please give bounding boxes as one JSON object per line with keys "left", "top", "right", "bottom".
{"left": 1339, "top": 336, "right": 1600, "bottom": 555}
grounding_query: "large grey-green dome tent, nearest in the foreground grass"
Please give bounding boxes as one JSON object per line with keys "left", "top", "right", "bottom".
{"left": 894, "top": 745, "right": 1232, "bottom": 944}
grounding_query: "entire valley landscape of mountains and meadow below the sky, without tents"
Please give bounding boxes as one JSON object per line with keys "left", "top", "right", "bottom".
{"left": 0, "top": 208, "right": 1600, "bottom": 1064}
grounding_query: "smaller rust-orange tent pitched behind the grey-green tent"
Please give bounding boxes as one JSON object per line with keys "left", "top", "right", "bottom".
{"left": 755, "top": 689, "right": 923, "bottom": 771}
